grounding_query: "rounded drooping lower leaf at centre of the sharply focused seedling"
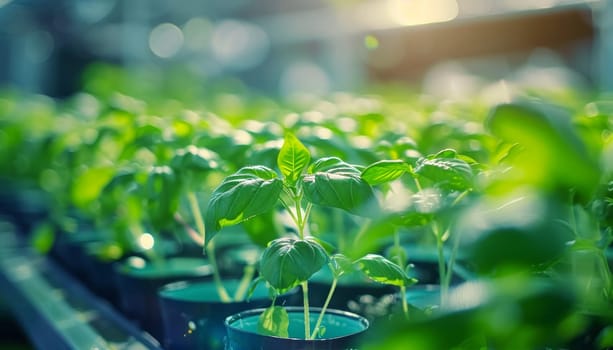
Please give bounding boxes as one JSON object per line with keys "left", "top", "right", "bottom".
{"left": 260, "top": 237, "right": 328, "bottom": 292}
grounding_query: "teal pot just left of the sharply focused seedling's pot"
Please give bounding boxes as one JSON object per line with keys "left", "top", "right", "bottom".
{"left": 158, "top": 279, "right": 300, "bottom": 350}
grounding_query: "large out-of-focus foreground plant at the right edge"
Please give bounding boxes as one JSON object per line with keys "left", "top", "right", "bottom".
{"left": 364, "top": 99, "right": 613, "bottom": 349}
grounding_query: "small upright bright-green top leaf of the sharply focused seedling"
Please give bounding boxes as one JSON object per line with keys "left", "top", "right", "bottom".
{"left": 277, "top": 133, "right": 311, "bottom": 186}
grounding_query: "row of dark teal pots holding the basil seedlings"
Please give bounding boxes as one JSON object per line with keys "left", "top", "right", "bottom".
{"left": 51, "top": 228, "right": 454, "bottom": 350}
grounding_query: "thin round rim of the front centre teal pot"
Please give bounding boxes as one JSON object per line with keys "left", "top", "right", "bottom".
{"left": 224, "top": 306, "right": 370, "bottom": 342}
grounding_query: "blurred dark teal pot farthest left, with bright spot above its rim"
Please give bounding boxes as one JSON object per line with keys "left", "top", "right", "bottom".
{"left": 115, "top": 257, "right": 212, "bottom": 341}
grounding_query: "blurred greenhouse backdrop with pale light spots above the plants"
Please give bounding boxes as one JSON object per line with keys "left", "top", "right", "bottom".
{"left": 0, "top": 0, "right": 613, "bottom": 96}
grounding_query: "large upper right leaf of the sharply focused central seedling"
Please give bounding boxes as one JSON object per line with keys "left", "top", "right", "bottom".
{"left": 302, "top": 157, "right": 379, "bottom": 216}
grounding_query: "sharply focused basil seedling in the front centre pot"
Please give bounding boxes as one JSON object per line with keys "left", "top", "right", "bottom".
{"left": 205, "top": 133, "right": 412, "bottom": 339}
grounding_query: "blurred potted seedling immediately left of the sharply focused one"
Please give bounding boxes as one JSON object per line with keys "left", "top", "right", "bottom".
{"left": 158, "top": 146, "right": 296, "bottom": 350}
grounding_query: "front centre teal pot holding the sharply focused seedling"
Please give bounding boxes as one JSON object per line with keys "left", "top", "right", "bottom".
{"left": 225, "top": 307, "right": 369, "bottom": 350}
